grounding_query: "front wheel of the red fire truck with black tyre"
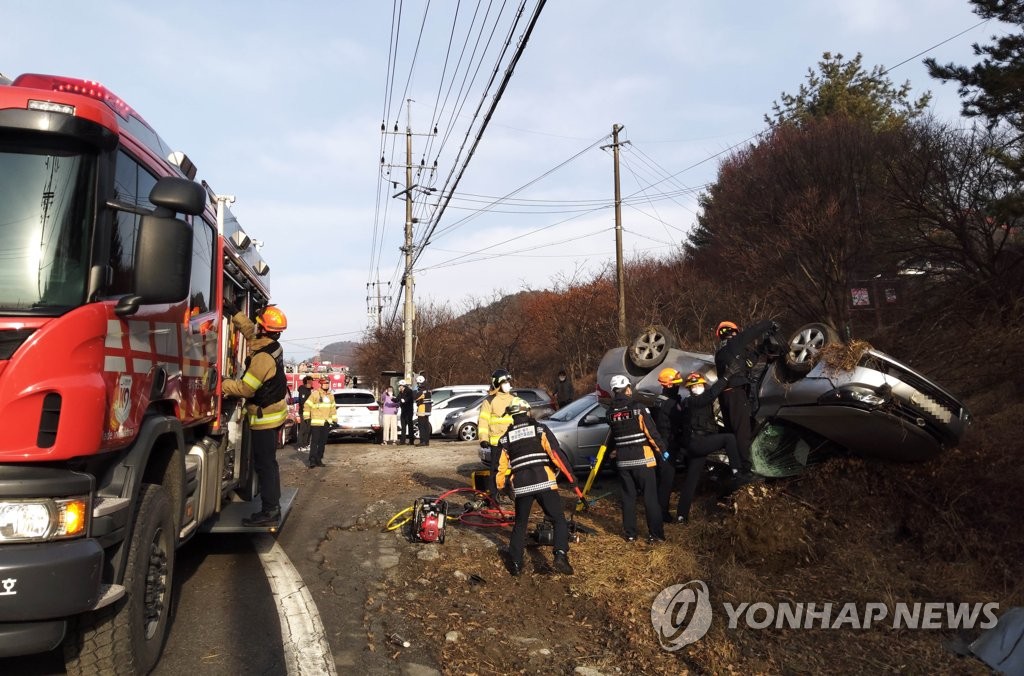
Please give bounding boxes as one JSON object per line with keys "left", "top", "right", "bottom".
{"left": 65, "top": 483, "right": 174, "bottom": 675}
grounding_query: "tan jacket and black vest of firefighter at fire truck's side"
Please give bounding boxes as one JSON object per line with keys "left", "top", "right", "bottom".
{"left": 221, "top": 312, "right": 288, "bottom": 429}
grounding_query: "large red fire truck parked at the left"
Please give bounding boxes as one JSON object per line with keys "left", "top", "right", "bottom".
{"left": 0, "top": 75, "right": 295, "bottom": 673}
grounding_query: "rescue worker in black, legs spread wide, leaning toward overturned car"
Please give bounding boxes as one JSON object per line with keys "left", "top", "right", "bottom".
{"left": 676, "top": 373, "right": 749, "bottom": 523}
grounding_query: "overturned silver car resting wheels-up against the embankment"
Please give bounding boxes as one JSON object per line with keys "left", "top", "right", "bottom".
{"left": 597, "top": 324, "right": 971, "bottom": 476}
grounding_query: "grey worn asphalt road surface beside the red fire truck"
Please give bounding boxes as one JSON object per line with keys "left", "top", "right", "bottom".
{"left": 0, "top": 440, "right": 475, "bottom": 676}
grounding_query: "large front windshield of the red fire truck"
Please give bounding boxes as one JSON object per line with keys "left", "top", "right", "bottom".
{"left": 0, "top": 144, "right": 96, "bottom": 314}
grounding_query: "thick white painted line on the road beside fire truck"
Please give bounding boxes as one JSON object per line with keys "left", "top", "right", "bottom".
{"left": 253, "top": 535, "right": 338, "bottom": 676}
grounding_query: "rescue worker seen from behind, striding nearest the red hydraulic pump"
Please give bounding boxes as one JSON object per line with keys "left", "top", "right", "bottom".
{"left": 492, "top": 397, "right": 575, "bottom": 576}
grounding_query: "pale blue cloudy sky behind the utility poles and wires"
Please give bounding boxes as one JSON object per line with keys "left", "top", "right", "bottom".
{"left": 0, "top": 0, "right": 1006, "bottom": 368}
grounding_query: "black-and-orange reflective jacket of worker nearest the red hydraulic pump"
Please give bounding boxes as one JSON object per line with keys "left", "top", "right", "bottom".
{"left": 495, "top": 416, "right": 565, "bottom": 498}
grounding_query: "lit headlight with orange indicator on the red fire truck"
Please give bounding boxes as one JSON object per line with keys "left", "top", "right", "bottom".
{"left": 0, "top": 498, "right": 89, "bottom": 542}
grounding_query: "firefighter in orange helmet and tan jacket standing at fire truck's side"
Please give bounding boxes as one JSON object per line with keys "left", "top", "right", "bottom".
{"left": 221, "top": 304, "right": 288, "bottom": 525}
